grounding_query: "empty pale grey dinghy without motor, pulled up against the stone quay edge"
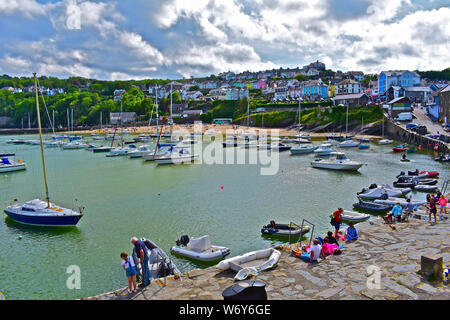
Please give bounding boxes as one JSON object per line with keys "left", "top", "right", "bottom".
{"left": 216, "top": 248, "right": 281, "bottom": 273}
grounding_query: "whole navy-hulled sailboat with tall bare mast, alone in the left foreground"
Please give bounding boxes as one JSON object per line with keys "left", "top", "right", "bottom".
{"left": 4, "top": 73, "right": 84, "bottom": 226}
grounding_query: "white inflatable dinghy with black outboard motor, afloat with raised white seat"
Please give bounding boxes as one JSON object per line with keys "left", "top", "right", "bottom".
{"left": 170, "top": 235, "right": 230, "bottom": 261}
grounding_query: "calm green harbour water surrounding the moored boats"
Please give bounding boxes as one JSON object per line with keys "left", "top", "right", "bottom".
{"left": 0, "top": 136, "right": 450, "bottom": 299}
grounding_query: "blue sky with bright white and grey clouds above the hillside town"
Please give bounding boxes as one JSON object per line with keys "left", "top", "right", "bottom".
{"left": 0, "top": 0, "right": 450, "bottom": 80}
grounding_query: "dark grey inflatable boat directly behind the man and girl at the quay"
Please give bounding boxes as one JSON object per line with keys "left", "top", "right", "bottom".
{"left": 132, "top": 238, "right": 181, "bottom": 279}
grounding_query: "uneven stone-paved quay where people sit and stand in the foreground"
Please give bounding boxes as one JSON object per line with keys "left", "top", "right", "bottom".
{"left": 86, "top": 208, "right": 450, "bottom": 300}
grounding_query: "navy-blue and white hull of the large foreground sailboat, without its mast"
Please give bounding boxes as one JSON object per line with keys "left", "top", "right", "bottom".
{"left": 5, "top": 199, "right": 83, "bottom": 226}
